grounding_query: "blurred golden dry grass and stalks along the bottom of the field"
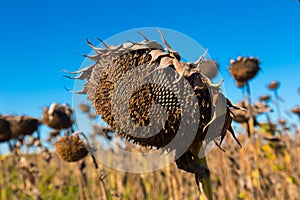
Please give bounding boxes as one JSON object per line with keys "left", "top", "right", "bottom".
{"left": 0, "top": 129, "right": 300, "bottom": 200}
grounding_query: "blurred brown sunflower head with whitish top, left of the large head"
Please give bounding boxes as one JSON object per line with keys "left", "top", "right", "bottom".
{"left": 42, "top": 103, "right": 73, "bottom": 130}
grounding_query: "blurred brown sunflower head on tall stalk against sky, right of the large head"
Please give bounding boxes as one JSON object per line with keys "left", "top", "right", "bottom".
{"left": 229, "top": 56, "right": 260, "bottom": 87}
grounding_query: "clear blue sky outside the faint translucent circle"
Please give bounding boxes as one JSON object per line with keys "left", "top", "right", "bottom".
{"left": 0, "top": 0, "right": 300, "bottom": 120}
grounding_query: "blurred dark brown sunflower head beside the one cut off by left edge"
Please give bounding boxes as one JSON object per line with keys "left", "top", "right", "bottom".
{"left": 3, "top": 115, "right": 40, "bottom": 138}
